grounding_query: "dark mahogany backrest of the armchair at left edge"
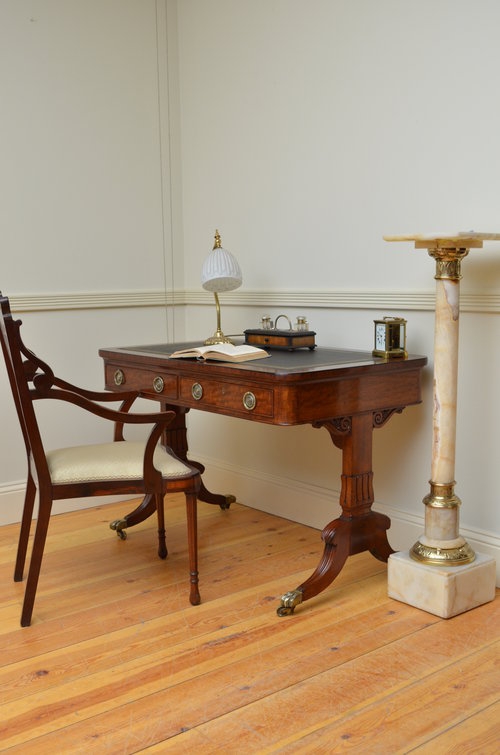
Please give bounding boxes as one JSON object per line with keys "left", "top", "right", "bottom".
{"left": 0, "top": 292, "right": 54, "bottom": 483}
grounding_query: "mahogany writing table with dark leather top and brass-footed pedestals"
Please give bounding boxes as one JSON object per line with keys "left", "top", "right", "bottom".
{"left": 99, "top": 343, "right": 427, "bottom": 615}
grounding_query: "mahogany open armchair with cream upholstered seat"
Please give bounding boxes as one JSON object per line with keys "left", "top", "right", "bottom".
{"left": 0, "top": 292, "right": 200, "bottom": 627}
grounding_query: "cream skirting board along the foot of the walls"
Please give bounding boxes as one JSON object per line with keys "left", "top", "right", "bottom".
{"left": 0, "top": 466, "right": 500, "bottom": 587}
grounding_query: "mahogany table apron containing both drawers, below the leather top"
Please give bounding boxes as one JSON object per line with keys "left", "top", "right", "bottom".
{"left": 105, "top": 361, "right": 421, "bottom": 425}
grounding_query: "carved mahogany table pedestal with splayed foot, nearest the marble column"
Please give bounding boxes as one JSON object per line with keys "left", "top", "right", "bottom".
{"left": 277, "top": 408, "right": 396, "bottom": 616}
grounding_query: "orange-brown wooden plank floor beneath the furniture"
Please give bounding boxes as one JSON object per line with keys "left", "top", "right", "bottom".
{"left": 0, "top": 496, "right": 500, "bottom": 755}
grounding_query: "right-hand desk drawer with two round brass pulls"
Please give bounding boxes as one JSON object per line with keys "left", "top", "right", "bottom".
{"left": 179, "top": 377, "right": 274, "bottom": 418}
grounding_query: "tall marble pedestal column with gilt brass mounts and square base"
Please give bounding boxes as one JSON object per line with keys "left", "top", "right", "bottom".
{"left": 385, "top": 233, "right": 500, "bottom": 618}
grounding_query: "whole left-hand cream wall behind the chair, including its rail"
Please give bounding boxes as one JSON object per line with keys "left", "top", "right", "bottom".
{"left": 0, "top": 0, "right": 183, "bottom": 522}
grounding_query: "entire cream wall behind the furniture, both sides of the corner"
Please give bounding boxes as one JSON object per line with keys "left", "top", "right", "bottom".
{"left": 0, "top": 0, "right": 500, "bottom": 580}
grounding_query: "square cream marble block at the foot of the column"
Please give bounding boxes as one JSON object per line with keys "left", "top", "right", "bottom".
{"left": 387, "top": 552, "right": 496, "bottom": 619}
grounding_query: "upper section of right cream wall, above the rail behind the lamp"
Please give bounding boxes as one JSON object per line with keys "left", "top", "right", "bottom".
{"left": 179, "top": 0, "right": 500, "bottom": 291}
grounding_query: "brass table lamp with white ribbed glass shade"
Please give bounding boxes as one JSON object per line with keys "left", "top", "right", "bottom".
{"left": 201, "top": 231, "right": 242, "bottom": 346}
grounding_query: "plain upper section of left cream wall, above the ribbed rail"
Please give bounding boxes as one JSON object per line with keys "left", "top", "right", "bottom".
{"left": 0, "top": 0, "right": 176, "bottom": 293}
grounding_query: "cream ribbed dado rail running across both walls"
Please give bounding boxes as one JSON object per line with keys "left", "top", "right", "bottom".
{"left": 10, "top": 288, "right": 500, "bottom": 314}
